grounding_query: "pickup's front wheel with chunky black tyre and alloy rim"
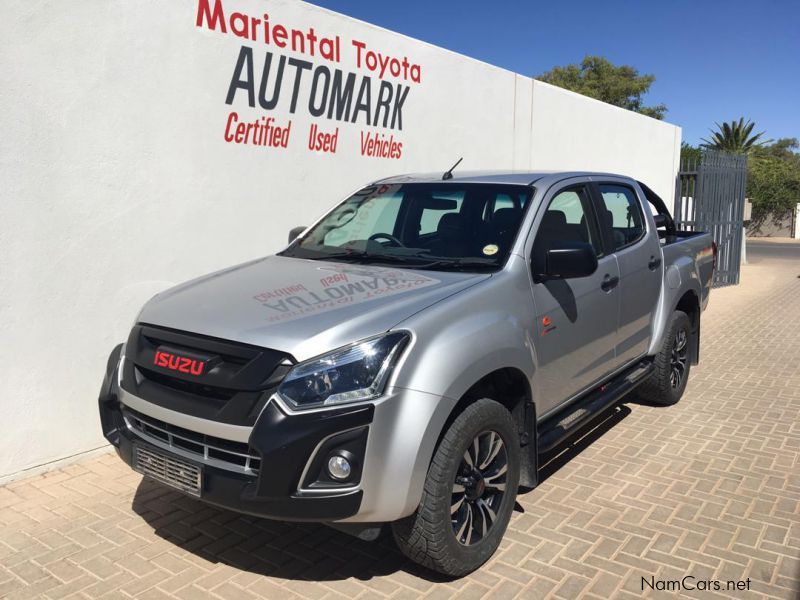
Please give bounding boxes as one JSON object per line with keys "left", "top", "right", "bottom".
{"left": 392, "top": 398, "right": 520, "bottom": 577}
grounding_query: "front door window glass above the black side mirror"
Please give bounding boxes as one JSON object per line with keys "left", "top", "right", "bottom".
{"left": 533, "top": 186, "right": 603, "bottom": 265}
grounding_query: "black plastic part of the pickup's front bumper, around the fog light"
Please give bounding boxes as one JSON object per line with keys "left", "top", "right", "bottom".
{"left": 99, "top": 344, "right": 374, "bottom": 522}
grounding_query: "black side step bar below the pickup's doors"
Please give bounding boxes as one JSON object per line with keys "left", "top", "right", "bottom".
{"left": 536, "top": 360, "right": 654, "bottom": 455}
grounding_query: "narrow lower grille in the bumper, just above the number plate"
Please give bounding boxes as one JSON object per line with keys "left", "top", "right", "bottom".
{"left": 123, "top": 408, "right": 261, "bottom": 476}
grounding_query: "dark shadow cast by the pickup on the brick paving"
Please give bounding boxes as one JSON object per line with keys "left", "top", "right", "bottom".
{"left": 133, "top": 406, "right": 631, "bottom": 582}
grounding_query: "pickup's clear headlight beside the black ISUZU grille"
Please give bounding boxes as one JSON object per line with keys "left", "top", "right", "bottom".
{"left": 278, "top": 332, "right": 409, "bottom": 409}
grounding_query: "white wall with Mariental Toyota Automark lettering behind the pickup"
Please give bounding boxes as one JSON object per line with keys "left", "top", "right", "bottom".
{"left": 0, "top": 0, "right": 680, "bottom": 477}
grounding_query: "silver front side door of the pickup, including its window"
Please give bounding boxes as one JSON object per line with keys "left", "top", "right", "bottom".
{"left": 529, "top": 181, "right": 620, "bottom": 418}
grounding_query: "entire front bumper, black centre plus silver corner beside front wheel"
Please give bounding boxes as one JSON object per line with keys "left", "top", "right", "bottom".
{"left": 99, "top": 347, "right": 454, "bottom": 523}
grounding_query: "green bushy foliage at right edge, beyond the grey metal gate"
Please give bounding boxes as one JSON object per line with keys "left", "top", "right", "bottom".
{"left": 747, "top": 138, "right": 800, "bottom": 223}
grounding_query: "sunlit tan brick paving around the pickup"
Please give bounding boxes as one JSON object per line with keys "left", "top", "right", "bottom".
{"left": 0, "top": 255, "right": 800, "bottom": 600}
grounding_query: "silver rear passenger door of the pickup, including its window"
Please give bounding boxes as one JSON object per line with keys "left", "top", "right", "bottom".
{"left": 593, "top": 179, "right": 664, "bottom": 366}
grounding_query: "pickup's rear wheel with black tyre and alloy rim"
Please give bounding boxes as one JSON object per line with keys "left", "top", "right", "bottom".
{"left": 634, "top": 310, "right": 692, "bottom": 406}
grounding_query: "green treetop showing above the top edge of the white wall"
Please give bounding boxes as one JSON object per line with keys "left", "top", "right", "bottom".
{"left": 536, "top": 56, "right": 667, "bottom": 119}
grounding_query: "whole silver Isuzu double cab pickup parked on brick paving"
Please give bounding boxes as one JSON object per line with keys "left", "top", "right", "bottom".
{"left": 99, "top": 172, "right": 716, "bottom": 576}
